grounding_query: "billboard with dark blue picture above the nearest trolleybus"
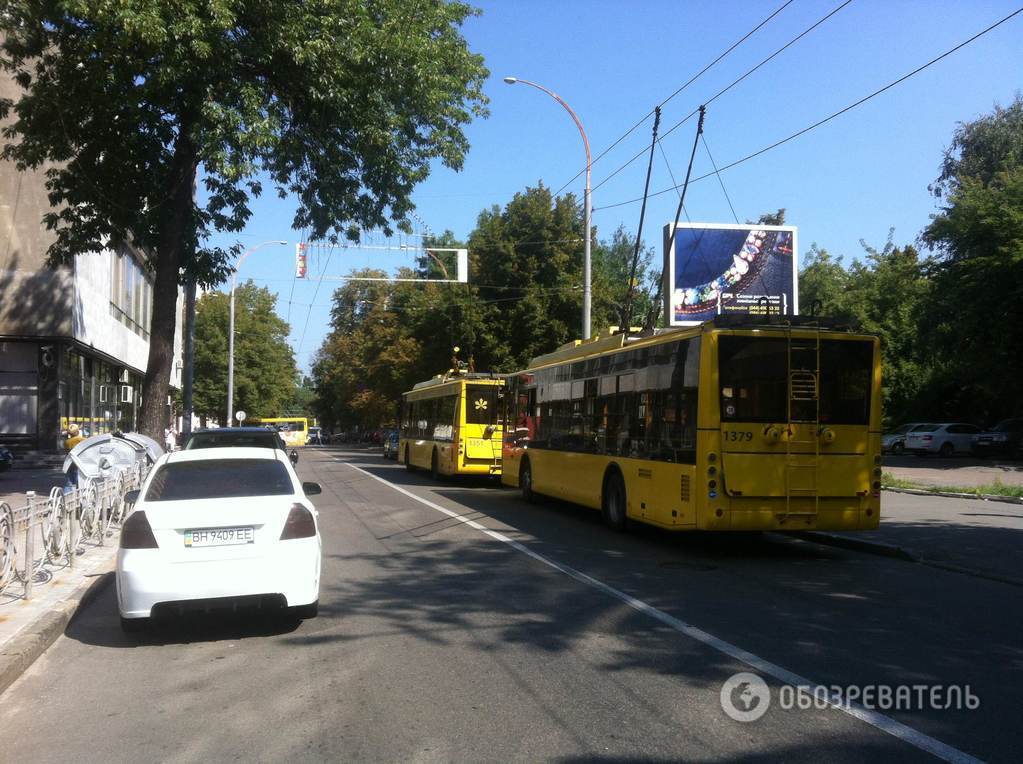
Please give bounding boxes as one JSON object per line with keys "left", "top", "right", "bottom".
{"left": 663, "top": 223, "right": 799, "bottom": 326}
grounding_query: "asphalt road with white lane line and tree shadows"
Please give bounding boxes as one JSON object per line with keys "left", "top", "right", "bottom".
{"left": 0, "top": 449, "right": 1023, "bottom": 762}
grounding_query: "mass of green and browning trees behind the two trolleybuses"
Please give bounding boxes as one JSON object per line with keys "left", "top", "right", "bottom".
{"left": 313, "top": 185, "right": 656, "bottom": 428}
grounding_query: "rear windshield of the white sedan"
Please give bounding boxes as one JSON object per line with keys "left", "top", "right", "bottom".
{"left": 145, "top": 459, "right": 295, "bottom": 501}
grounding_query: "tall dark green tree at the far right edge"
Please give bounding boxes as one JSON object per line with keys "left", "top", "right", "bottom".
{"left": 922, "top": 96, "right": 1023, "bottom": 421}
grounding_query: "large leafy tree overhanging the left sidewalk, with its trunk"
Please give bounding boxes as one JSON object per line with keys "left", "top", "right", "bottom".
{"left": 0, "top": 0, "right": 487, "bottom": 435}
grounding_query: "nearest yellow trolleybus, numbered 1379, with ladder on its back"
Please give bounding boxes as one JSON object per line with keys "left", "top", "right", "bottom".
{"left": 501, "top": 316, "right": 881, "bottom": 531}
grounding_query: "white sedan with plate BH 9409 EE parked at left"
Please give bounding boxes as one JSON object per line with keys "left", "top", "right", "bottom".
{"left": 117, "top": 448, "right": 321, "bottom": 631}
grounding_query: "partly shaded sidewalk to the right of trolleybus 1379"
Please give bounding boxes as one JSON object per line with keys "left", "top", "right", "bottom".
{"left": 807, "top": 491, "right": 1023, "bottom": 586}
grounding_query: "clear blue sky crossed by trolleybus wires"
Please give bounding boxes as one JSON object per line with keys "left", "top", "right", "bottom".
{"left": 209, "top": 0, "right": 1023, "bottom": 370}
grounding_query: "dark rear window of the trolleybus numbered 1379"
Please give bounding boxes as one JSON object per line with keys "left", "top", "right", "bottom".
{"left": 718, "top": 335, "right": 874, "bottom": 424}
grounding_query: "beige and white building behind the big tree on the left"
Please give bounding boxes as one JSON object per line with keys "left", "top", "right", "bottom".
{"left": 0, "top": 72, "right": 182, "bottom": 451}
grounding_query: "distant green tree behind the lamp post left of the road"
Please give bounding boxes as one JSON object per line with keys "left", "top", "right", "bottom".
{"left": 193, "top": 281, "right": 298, "bottom": 422}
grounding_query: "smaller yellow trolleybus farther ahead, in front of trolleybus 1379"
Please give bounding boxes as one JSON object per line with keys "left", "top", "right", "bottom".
{"left": 398, "top": 372, "right": 503, "bottom": 478}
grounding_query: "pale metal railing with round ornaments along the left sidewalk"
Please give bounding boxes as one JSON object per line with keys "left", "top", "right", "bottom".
{"left": 0, "top": 462, "right": 148, "bottom": 599}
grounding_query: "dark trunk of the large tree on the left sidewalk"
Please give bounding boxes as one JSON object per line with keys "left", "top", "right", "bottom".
{"left": 138, "top": 133, "right": 198, "bottom": 443}
